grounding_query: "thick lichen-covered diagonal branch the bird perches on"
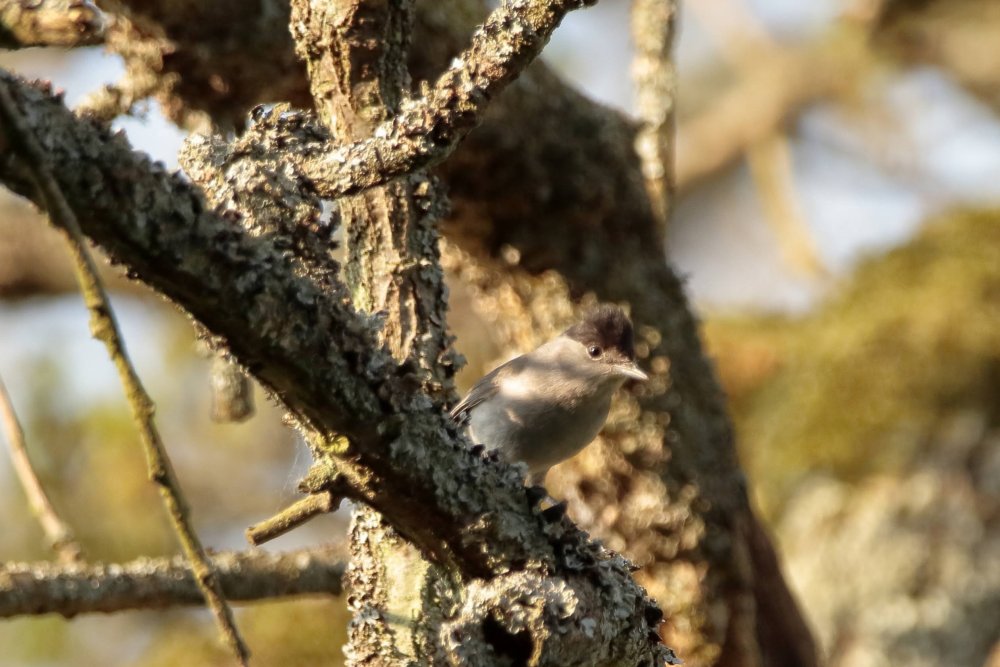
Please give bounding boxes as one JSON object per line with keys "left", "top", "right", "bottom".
{"left": 0, "top": 70, "right": 670, "bottom": 664}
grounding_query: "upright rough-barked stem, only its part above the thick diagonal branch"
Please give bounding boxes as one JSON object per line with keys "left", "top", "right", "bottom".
{"left": 292, "top": 0, "right": 455, "bottom": 398}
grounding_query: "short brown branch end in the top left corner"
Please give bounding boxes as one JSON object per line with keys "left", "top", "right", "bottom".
{"left": 0, "top": 0, "right": 105, "bottom": 49}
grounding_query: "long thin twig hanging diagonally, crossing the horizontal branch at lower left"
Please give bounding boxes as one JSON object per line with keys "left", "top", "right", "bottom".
{"left": 0, "top": 81, "right": 250, "bottom": 665}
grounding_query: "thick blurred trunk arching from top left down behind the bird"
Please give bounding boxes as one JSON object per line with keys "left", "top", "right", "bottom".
{"left": 0, "top": 1, "right": 812, "bottom": 664}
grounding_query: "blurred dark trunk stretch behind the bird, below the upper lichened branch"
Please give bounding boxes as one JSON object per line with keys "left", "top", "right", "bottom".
{"left": 443, "top": 66, "right": 816, "bottom": 665}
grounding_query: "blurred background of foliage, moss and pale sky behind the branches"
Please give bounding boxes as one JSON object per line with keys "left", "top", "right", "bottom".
{"left": 0, "top": 0, "right": 1000, "bottom": 667}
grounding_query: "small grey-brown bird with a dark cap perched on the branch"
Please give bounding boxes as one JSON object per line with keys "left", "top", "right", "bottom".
{"left": 451, "top": 304, "right": 649, "bottom": 484}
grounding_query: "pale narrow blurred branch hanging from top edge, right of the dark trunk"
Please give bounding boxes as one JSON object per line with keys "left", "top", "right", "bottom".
{"left": 632, "top": 0, "right": 677, "bottom": 229}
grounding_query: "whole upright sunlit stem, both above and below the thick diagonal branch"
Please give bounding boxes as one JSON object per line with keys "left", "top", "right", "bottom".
{"left": 292, "top": 0, "right": 459, "bottom": 665}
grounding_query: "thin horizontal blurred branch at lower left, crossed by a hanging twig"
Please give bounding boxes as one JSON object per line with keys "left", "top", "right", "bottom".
{"left": 0, "top": 549, "right": 345, "bottom": 618}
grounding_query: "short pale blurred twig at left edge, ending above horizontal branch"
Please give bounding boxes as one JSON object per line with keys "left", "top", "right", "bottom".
{"left": 0, "top": 379, "right": 83, "bottom": 563}
